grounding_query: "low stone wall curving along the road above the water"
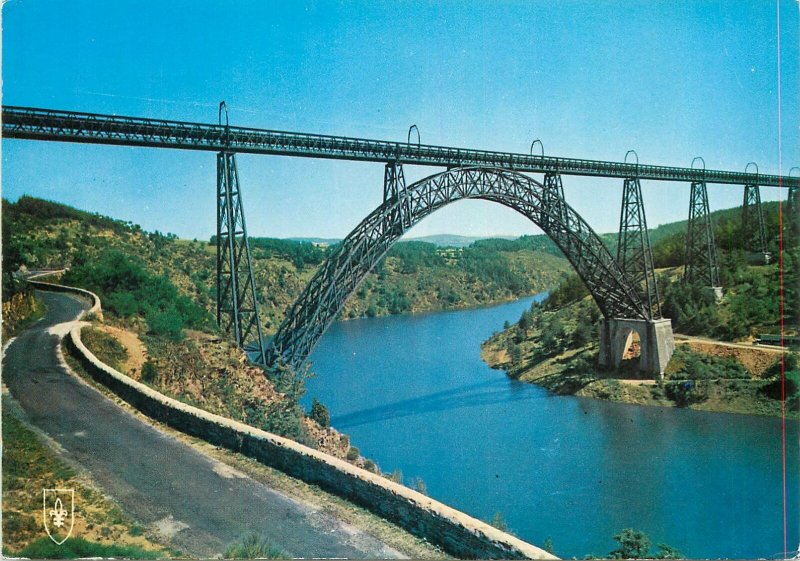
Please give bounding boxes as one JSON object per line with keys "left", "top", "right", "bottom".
{"left": 47, "top": 283, "right": 557, "bottom": 559}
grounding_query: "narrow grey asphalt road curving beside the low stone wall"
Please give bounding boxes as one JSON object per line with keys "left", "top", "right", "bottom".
{"left": 2, "top": 292, "right": 402, "bottom": 558}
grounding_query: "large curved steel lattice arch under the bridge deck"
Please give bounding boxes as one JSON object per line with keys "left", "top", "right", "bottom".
{"left": 268, "top": 168, "right": 650, "bottom": 367}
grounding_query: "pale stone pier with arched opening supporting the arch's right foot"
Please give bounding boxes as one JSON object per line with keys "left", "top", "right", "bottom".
{"left": 599, "top": 318, "right": 675, "bottom": 380}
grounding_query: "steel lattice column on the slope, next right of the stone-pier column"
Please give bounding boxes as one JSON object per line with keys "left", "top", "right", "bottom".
{"left": 683, "top": 181, "right": 720, "bottom": 288}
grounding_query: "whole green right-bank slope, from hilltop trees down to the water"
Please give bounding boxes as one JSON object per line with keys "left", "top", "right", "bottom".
{"left": 483, "top": 197, "right": 799, "bottom": 418}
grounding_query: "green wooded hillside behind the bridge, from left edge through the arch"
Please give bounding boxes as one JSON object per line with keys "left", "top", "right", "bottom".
{"left": 2, "top": 196, "right": 570, "bottom": 333}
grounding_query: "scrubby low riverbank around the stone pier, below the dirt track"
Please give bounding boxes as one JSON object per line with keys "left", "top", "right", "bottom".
{"left": 481, "top": 303, "right": 800, "bottom": 419}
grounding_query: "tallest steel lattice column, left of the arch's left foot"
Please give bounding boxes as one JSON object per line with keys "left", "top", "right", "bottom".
{"left": 217, "top": 152, "right": 266, "bottom": 364}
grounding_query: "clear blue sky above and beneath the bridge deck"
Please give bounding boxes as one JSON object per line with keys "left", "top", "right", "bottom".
{"left": 2, "top": 0, "right": 800, "bottom": 239}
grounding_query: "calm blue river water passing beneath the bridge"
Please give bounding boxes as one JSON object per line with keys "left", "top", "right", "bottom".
{"left": 305, "top": 299, "right": 800, "bottom": 558}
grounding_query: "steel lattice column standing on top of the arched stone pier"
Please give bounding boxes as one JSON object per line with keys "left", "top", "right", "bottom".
{"left": 617, "top": 177, "right": 661, "bottom": 319}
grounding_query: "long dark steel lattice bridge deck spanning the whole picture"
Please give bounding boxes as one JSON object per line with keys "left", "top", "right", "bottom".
{"left": 3, "top": 106, "right": 800, "bottom": 187}
